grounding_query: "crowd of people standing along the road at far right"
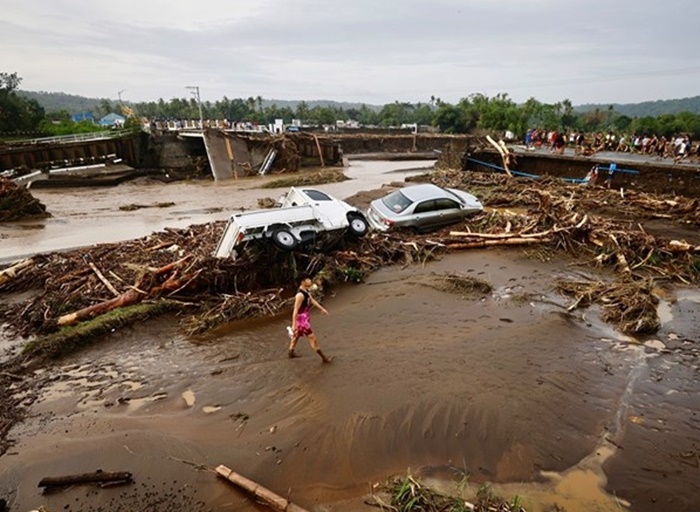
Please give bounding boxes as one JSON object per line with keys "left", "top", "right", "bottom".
{"left": 525, "top": 129, "right": 700, "bottom": 162}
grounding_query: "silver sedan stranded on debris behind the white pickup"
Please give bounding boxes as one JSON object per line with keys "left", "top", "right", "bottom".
{"left": 367, "top": 183, "right": 484, "bottom": 233}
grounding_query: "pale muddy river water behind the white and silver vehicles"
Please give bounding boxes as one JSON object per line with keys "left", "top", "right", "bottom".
{"left": 0, "top": 161, "right": 434, "bottom": 263}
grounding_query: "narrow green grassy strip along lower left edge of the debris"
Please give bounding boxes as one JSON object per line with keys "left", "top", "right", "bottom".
{"left": 22, "top": 301, "right": 182, "bottom": 357}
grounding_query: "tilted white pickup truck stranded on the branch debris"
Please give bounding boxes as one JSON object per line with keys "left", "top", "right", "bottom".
{"left": 214, "top": 187, "right": 369, "bottom": 258}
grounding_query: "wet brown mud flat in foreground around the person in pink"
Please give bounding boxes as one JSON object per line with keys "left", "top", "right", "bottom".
{"left": 0, "top": 164, "right": 700, "bottom": 512}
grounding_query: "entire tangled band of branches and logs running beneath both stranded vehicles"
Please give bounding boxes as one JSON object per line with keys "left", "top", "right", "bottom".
{"left": 0, "top": 168, "right": 700, "bottom": 356}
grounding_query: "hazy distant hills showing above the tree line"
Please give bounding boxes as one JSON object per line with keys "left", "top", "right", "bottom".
{"left": 18, "top": 91, "right": 700, "bottom": 117}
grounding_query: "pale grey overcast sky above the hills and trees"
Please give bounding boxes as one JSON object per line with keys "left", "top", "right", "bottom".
{"left": 0, "top": 0, "right": 700, "bottom": 105}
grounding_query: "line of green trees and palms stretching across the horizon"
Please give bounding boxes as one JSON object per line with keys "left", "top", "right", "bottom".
{"left": 0, "top": 73, "right": 700, "bottom": 139}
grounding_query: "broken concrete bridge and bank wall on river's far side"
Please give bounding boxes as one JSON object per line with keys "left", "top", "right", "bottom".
{"left": 0, "top": 128, "right": 454, "bottom": 186}
